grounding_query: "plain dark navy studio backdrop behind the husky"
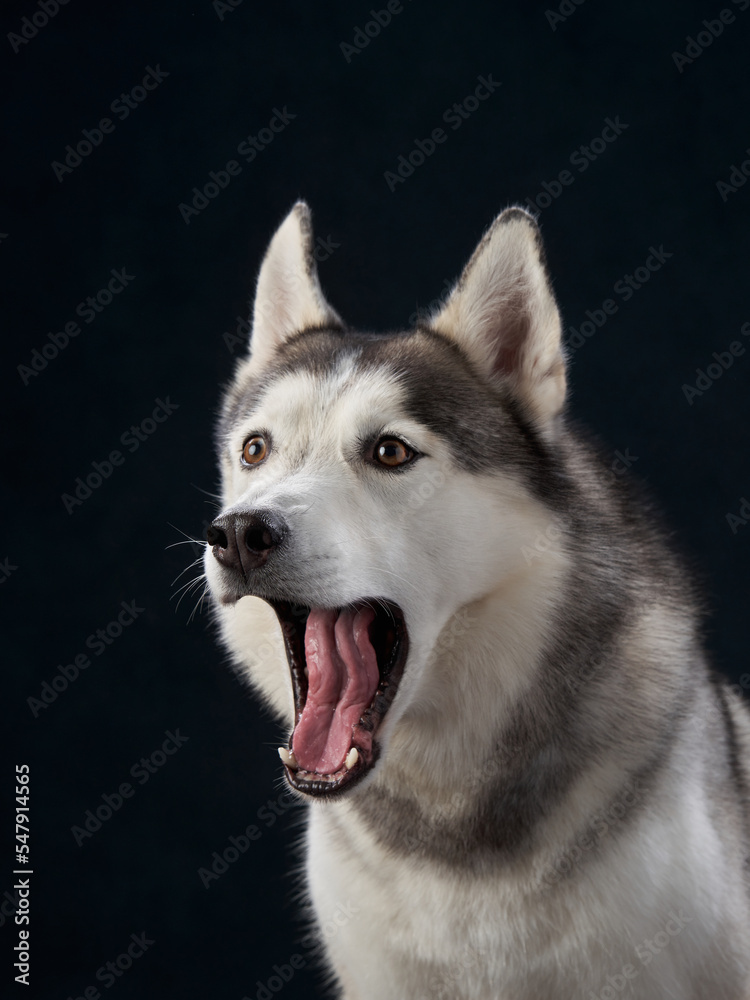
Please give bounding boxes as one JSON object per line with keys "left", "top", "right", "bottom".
{"left": 0, "top": 0, "right": 750, "bottom": 1000}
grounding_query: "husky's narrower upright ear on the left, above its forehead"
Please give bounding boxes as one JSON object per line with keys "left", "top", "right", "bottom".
{"left": 250, "top": 201, "right": 343, "bottom": 367}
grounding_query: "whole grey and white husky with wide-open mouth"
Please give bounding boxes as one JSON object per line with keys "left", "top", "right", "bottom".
{"left": 205, "top": 203, "right": 750, "bottom": 1000}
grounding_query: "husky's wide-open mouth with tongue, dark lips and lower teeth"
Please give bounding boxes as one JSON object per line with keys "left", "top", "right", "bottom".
{"left": 269, "top": 599, "right": 408, "bottom": 797}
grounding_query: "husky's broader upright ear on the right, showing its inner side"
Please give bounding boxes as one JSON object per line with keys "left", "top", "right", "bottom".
{"left": 429, "top": 208, "right": 565, "bottom": 428}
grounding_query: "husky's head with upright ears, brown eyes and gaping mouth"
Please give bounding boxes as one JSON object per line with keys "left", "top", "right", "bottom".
{"left": 205, "top": 203, "right": 565, "bottom": 796}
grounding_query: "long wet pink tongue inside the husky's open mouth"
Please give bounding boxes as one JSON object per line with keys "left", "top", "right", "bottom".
{"left": 292, "top": 608, "right": 380, "bottom": 774}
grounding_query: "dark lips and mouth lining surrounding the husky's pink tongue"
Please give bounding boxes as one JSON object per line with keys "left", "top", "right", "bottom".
{"left": 266, "top": 598, "right": 409, "bottom": 799}
